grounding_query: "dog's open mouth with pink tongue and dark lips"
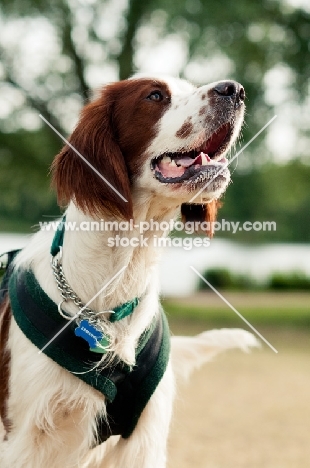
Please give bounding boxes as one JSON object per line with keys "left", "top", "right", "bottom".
{"left": 151, "top": 123, "right": 232, "bottom": 183}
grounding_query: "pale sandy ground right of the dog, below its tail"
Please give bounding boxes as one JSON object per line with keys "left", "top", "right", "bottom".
{"left": 169, "top": 326, "right": 310, "bottom": 468}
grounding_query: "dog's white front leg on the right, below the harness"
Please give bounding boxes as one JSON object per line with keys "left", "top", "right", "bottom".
{"left": 100, "top": 363, "right": 174, "bottom": 468}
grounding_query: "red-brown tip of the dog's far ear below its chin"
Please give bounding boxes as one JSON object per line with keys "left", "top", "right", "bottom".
{"left": 181, "top": 200, "right": 221, "bottom": 237}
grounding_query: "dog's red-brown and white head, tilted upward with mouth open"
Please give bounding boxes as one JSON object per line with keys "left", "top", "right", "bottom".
{"left": 53, "top": 75, "right": 244, "bottom": 227}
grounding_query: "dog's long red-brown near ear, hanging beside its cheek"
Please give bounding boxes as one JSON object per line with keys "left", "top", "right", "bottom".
{"left": 52, "top": 88, "right": 133, "bottom": 220}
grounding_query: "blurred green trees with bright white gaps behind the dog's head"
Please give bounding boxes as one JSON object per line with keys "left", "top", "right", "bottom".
{"left": 0, "top": 0, "right": 310, "bottom": 242}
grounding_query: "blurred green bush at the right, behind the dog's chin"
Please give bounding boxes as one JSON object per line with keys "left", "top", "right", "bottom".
{"left": 218, "top": 160, "right": 310, "bottom": 243}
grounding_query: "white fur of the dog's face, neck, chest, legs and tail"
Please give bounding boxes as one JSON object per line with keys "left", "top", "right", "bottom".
{"left": 0, "top": 75, "right": 257, "bottom": 468}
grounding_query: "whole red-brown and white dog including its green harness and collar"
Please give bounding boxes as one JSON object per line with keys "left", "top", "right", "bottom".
{"left": 0, "top": 75, "right": 257, "bottom": 468}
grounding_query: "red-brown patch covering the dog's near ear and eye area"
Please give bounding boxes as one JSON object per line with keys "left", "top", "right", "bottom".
{"left": 52, "top": 79, "right": 170, "bottom": 219}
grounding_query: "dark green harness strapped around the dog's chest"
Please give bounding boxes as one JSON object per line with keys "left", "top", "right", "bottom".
{"left": 0, "top": 221, "right": 170, "bottom": 445}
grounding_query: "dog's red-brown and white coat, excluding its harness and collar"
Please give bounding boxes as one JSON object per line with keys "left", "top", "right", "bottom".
{"left": 0, "top": 75, "right": 257, "bottom": 468}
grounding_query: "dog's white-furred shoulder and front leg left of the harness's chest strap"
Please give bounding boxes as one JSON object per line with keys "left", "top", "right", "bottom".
{"left": 0, "top": 320, "right": 104, "bottom": 468}
